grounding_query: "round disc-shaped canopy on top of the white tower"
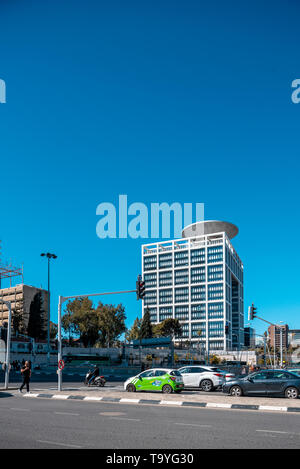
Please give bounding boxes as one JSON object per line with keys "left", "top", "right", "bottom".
{"left": 182, "top": 220, "right": 239, "bottom": 239}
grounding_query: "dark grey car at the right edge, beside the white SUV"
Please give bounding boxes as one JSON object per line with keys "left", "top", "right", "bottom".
{"left": 222, "top": 370, "right": 300, "bottom": 399}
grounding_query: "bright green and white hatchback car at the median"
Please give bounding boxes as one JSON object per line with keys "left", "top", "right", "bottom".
{"left": 124, "top": 368, "right": 184, "bottom": 394}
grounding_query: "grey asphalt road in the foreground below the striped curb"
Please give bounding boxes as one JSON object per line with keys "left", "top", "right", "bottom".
{"left": 0, "top": 392, "right": 300, "bottom": 449}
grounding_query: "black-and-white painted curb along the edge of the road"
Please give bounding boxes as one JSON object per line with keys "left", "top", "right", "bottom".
{"left": 23, "top": 393, "right": 300, "bottom": 412}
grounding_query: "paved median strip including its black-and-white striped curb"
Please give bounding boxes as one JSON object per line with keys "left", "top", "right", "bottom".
{"left": 13, "top": 388, "right": 300, "bottom": 412}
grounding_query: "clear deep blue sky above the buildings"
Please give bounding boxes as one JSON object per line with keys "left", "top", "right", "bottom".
{"left": 0, "top": 0, "right": 300, "bottom": 332}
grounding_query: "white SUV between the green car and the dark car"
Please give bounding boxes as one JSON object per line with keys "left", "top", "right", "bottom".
{"left": 178, "top": 365, "right": 225, "bottom": 392}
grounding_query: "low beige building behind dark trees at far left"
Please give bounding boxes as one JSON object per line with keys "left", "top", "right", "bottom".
{"left": 0, "top": 283, "right": 48, "bottom": 334}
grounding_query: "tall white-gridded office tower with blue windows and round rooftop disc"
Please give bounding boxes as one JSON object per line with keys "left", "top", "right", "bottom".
{"left": 142, "top": 221, "right": 244, "bottom": 351}
